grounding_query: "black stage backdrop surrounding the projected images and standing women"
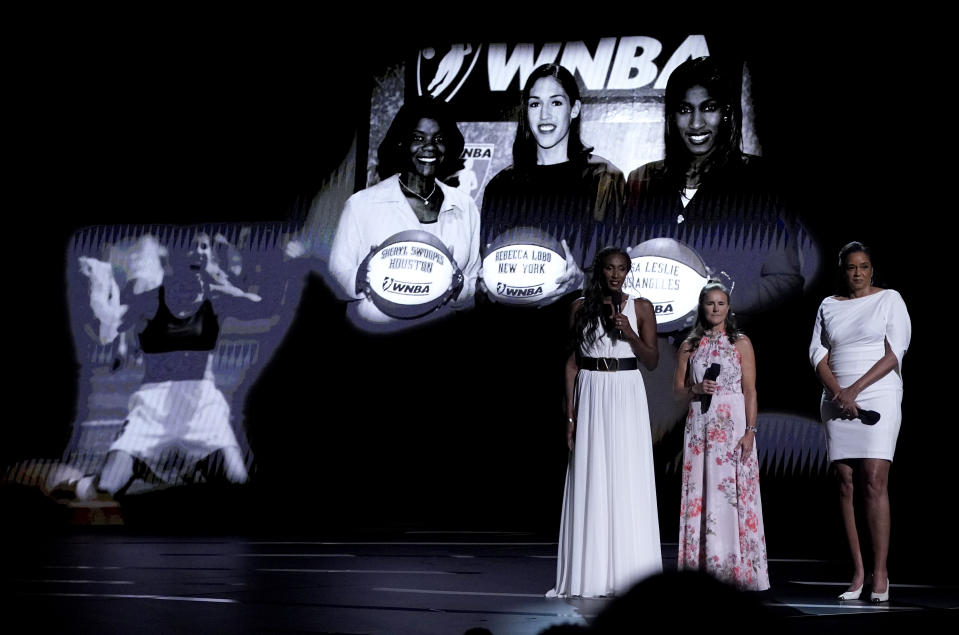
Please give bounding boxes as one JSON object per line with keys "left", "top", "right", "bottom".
{"left": 7, "top": 15, "right": 959, "bottom": 559}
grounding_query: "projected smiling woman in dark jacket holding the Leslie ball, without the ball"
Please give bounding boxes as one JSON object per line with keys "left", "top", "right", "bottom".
{"left": 626, "top": 57, "right": 804, "bottom": 316}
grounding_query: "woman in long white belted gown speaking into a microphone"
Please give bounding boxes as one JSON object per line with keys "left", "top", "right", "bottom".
{"left": 547, "top": 247, "right": 663, "bottom": 597}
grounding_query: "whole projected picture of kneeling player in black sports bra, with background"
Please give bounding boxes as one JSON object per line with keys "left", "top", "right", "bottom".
{"left": 9, "top": 223, "right": 306, "bottom": 522}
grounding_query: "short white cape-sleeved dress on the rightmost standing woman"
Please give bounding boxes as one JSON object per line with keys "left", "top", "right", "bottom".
{"left": 809, "top": 289, "right": 912, "bottom": 461}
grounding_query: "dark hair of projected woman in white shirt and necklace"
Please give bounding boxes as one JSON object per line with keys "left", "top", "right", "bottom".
{"left": 376, "top": 97, "right": 466, "bottom": 181}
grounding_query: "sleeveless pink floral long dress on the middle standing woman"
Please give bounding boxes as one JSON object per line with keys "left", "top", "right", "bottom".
{"left": 677, "top": 333, "right": 769, "bottom": 591}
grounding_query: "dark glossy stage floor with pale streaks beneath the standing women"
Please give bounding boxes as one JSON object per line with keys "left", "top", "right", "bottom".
{"left": 2, "top": 527, "right": 959, "bottom": 635}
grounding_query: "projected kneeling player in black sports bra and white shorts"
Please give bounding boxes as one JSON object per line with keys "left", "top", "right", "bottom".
{"left": 68, "top": 233, "right": 260, "bottom": 500}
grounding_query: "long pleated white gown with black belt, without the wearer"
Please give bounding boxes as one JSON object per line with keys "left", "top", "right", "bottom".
{"left": 546, "top": 301, "right": 663, "bottom": 597}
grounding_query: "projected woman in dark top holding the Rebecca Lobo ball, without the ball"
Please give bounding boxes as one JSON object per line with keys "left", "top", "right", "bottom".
{"left": 482, "top": 64, "right": 625, "bottom": 306}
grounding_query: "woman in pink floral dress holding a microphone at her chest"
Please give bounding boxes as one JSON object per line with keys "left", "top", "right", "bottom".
{"left": 673, "top": 282, "right": 769, "bottom": 591}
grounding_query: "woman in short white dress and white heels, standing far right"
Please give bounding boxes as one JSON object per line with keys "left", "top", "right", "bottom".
{"left": 809, "top": 242, "right": 911, "bottom": 602}
